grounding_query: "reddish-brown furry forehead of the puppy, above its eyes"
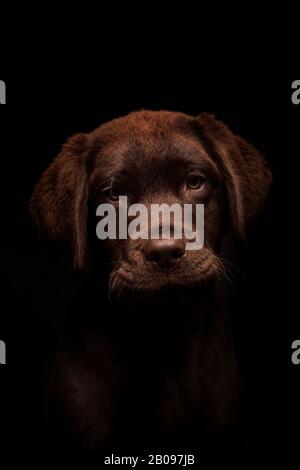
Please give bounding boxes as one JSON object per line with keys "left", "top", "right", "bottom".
{"left": 91, "top": 112, "right": 218, "bottom": 177}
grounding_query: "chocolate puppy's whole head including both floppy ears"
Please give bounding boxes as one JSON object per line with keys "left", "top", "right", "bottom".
{"left": 30, "top": 111, "right": 271, "bottom": 293}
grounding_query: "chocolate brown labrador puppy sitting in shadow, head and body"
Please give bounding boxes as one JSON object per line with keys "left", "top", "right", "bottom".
{"left": 30, "top": 111, "right": 271, "bottom": 448}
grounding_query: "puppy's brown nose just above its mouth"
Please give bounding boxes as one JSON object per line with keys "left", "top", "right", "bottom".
{"left": 144, "top": 239, "right": 185, "bottom": 271}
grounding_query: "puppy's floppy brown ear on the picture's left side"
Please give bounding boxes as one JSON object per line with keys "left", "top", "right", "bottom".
{"left": 29, "top": 134, "right": 88, "bottom": 268}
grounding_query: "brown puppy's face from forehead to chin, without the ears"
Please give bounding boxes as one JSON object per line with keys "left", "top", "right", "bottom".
{"left": 90, "top": 114, "right": 224, "bottom": 293}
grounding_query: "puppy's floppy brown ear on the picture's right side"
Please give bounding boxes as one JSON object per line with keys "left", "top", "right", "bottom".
{"left": 197, "top": 113, "right": 272, "bottom": 238}
